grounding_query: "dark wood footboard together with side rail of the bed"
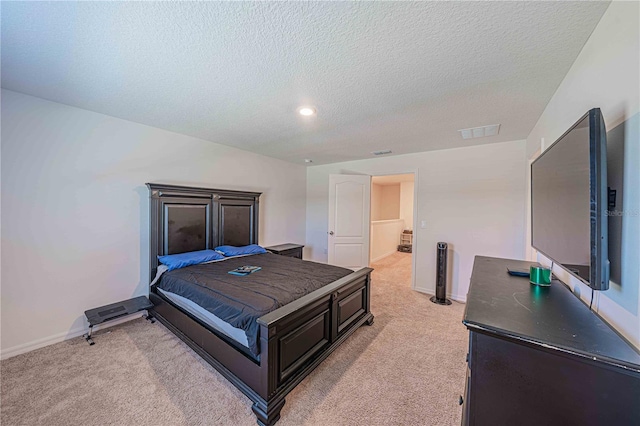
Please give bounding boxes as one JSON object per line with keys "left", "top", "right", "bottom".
{"left": 149, "top": 268, "right": 373, "bottom": 426}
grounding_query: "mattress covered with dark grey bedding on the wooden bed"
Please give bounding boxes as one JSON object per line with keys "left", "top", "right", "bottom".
{"left": 156, "top": 253, "right": 352, "bottom": 356}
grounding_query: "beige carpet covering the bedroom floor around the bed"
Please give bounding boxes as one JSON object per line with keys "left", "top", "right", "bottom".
{"left": 0, "top": 253, "right": 467, "bottom": 426}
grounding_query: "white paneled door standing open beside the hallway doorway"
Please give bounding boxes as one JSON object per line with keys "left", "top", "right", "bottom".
{"left": 328, "top": 175, "right": 371, "bottom": 268}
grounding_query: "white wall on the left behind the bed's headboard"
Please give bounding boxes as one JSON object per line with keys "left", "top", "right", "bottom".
{"left": 1, "top": 90, "right": 306, "bottom": 357}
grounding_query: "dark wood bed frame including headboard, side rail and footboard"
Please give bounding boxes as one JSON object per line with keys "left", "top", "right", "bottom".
{"left": 147, "top": 183, "right": 373, "bottom": 425}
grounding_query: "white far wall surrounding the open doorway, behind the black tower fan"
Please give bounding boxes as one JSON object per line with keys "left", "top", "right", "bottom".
{"left": 305, "top": 141, "right": 526, "bottom": 300}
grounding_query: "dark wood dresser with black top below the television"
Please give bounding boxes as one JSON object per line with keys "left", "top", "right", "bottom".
{"left": 461, "top": 256, "right": 640, "bottom": 426}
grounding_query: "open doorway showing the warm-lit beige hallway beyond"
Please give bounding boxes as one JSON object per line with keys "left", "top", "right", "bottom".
{"left": 370, "top": 173, "right": 415, "bottom": 283}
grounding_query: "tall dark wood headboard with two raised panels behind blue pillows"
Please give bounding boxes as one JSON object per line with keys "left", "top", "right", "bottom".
{"left": 147, "top": 183, "right": 261, "bottom": 280}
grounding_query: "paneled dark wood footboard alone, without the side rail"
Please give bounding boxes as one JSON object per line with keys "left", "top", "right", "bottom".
{"left": 253, "top": 268, "right": 373, "bottom": 425}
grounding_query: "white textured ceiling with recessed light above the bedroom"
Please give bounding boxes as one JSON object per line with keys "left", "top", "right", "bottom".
{"left": 2, "top": 2, "right": 608, "bottom": 164}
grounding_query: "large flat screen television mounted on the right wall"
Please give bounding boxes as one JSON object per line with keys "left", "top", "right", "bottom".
{"left": 531, "top": 108, "right": 609, "bottom": 290}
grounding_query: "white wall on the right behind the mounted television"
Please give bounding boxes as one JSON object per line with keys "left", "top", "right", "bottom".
{"left": 527, "top": 1, "right": 640, "bottom": 348}
